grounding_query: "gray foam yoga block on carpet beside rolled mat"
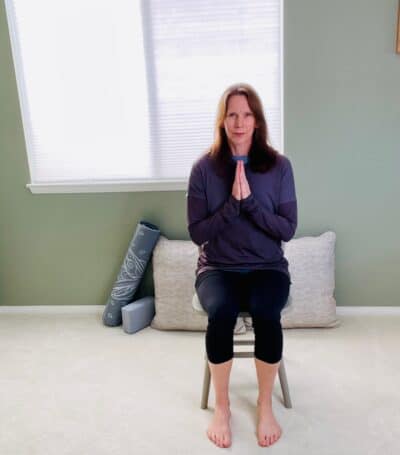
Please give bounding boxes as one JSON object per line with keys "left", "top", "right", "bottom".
{"left": 122, "top": 297, "right": 155, "bottom": 333}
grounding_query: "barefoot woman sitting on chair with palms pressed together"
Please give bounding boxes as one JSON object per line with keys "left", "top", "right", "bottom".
{"left": 187, "top": 84, "right": 297, "bottom": 447}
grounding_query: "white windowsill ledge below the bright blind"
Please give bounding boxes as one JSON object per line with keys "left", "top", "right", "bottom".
{"left": 26, "top": 179, "right": 188, "bottom": 194}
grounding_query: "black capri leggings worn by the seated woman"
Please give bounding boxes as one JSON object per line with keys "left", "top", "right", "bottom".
{"left": 195, "top": 270, "right": 291, "bottom": 363}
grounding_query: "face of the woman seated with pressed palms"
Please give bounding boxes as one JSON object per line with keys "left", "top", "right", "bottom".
{"left": 224, "top": 95, "right": 257, "bottom": 153}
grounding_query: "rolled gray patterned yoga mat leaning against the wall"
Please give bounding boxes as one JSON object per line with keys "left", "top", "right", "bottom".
{"left": 103, "top": 221, "right": 161, "bottom": 327}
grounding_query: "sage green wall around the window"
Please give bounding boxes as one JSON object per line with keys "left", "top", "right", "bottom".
{"left": 0, "top": 0, "right": 400, "bottom": 306}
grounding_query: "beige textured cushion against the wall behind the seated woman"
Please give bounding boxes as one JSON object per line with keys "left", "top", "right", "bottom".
{"left": 151, "top": 231, "right": 340, "bottom": 333}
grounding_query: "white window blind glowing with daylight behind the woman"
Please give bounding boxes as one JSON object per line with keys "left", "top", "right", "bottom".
{"left": 6, "top": 0, "right": 282, "bottom": 192}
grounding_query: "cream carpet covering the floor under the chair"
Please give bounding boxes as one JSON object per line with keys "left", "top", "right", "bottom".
{"left": 0, "top": 306, "right": 400, "bottom": 455}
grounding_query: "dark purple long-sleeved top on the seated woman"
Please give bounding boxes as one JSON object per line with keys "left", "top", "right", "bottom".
{"left": 187, "top": 154, "right": 297, "bottom": 278}
